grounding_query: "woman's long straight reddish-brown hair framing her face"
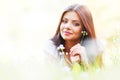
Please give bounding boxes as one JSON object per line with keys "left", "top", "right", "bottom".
{"left": 51, "top": 4, "right": 96, "bottom": 47}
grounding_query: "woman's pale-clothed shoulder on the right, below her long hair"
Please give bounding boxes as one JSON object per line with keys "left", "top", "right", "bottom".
{"left": 84, "top": 39, "right": 104, "bottom": 62}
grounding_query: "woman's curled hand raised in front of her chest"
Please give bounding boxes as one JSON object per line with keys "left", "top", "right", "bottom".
{"left": 70, "top": 43, "right": 88, "bottom": 65}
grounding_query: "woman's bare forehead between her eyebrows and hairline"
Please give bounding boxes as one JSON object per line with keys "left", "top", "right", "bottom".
{"left": 63, "top": 11, "right": 80, "bottom": 21}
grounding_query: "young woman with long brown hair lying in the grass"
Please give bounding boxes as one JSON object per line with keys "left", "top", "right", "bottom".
{"left": 44, "top": 4, "right": 102, "bottom": 68}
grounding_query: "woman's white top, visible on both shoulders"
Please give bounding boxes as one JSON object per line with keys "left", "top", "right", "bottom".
{"left": 43, "top": 40, "right": 103, "bottom": 63}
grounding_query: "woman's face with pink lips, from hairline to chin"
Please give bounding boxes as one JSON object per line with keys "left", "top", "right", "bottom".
{"left": 60, "top": 11, "right": 82, "bottom": 41}
